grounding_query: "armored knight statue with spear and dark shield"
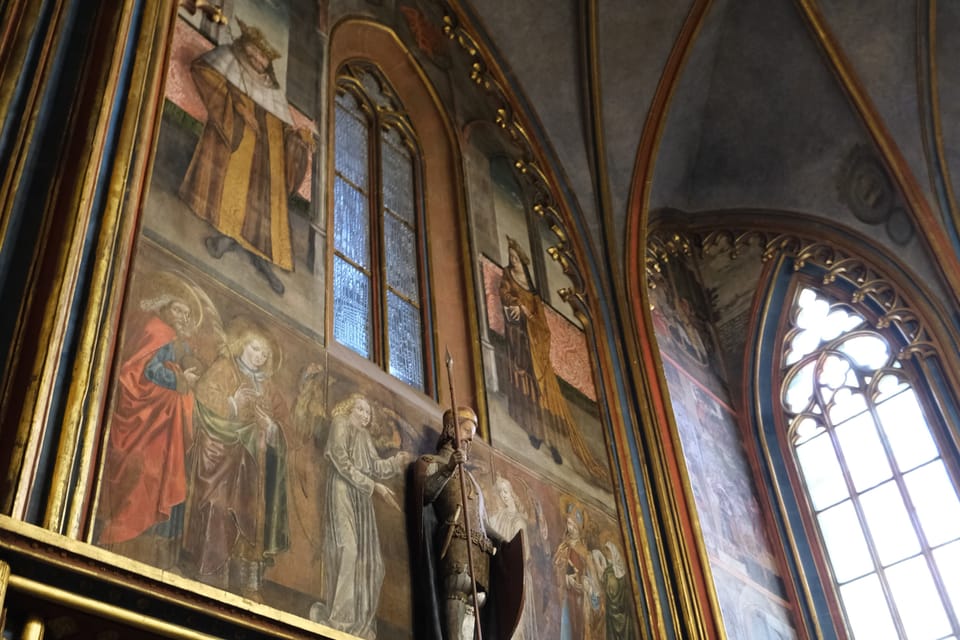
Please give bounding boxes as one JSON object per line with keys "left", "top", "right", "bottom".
{"left": 413, "top": 407, "right": 523, "bottom": 640}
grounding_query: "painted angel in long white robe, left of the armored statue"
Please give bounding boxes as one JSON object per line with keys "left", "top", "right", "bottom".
{"left": 309, "top": 393, "right": 413, "bottom": 638}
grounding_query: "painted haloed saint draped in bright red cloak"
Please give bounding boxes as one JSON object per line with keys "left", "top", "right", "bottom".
{"left": 96, "top": 272, "right": 212, "bottom": 546}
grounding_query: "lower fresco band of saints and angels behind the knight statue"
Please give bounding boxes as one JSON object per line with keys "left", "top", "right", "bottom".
{"left": 92, "top": 239, "right": 635, "bottom": 638}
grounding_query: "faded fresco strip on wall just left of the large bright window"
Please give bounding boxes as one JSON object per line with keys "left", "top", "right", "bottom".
{"left": 654, "top": 252, "right": 796, "bottom": 640}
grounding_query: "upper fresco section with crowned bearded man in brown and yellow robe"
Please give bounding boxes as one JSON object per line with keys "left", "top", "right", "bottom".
{"left": 142, "top": 1, "right": 325, "bottom": 337}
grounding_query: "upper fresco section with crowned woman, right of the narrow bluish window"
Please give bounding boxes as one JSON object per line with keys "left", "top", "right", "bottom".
{"left": 465, "top": 140, "right": 611, "bottom": 504}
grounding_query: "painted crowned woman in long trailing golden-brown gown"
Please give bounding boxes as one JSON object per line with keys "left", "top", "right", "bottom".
{"left": 500, "top": 236, "right": 608, "bottom": 479}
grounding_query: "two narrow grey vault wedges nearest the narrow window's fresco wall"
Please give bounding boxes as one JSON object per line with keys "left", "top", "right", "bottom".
{"left": 460, "top": 0, "right": 691, "bottom": 276}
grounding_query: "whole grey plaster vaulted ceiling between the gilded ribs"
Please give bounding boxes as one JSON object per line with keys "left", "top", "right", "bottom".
{"left": 469, "top": 0, "right": 952, "bottom": 298}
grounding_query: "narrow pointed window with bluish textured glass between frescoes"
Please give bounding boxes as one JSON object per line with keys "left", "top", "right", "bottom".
{"left": 331, "top": 61, "right": 433, "bottom": 393}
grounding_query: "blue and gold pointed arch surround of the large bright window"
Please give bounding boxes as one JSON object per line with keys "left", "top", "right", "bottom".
{"left": 747, "top": 255, "right": 960, "bottom": 639}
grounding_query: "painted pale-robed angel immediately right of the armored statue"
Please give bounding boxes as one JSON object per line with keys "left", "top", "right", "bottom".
{"left": 489, "top": 475, "right": 549, "bottom": 640}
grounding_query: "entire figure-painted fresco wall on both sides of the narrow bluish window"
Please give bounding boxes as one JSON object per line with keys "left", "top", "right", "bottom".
{"left": 89, "top": 0, "right": 638, "bottom": 640}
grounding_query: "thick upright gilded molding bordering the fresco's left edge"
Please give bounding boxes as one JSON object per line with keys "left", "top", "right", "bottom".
{"left": 43, "top": 0, "right": 176, "bottom": 538}
